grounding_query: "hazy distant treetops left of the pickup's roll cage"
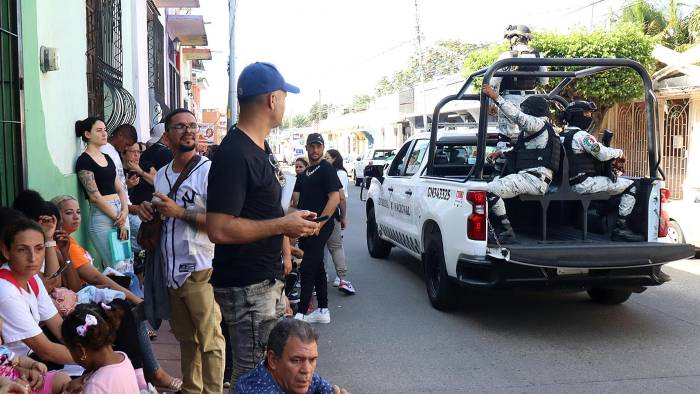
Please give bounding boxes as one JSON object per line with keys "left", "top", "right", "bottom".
{"left": 374, "top": 40, "right": 476, "bottom": 96}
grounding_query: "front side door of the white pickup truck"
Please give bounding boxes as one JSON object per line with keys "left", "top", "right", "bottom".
{"left": 375, "top": 141, "right": 413, "bottom": 245}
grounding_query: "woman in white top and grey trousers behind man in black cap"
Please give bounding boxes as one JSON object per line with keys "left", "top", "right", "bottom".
{"left": 324, "top": 149, "right": 355, "bottom": 295}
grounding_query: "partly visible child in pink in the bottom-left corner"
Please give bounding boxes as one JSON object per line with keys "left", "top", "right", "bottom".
{"left": 0, "top": 320, "right": 70, "bottom": 394}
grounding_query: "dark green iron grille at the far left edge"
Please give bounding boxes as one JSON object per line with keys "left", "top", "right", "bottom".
{"left": 0, "top": 0, "right": 24, "bottom": 206}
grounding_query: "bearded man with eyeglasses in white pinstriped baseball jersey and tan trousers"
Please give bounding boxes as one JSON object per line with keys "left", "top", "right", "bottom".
{"left": 137, "top": 108, "right": 225, "bottom": 393}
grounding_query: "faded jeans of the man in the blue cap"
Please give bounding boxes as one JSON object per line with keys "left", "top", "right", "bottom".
{"left": 214, "top": 280, "right": 284, "bottom": 386}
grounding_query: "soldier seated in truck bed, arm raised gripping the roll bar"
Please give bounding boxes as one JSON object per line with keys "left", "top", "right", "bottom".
{"left": 482, "top": 84, "right": 560, "bottom": 243}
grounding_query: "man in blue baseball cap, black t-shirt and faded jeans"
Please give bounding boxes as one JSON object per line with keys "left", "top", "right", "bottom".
{"left": 207, "top": 63, "right": 319, "bottom": 382}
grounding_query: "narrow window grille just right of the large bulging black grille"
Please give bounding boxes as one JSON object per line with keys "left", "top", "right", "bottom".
{"left": 147, "top": 0, "right": 165, "bottom": 106}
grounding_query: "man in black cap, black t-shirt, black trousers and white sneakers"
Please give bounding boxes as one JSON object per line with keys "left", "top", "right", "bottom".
{"left": 292, "top": 133, "right": 342, "bottom": 323}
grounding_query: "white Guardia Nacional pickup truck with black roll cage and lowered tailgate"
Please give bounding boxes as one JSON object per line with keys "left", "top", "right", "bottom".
{"left": 361, "top": 59, "right": 694, "bottom": 309}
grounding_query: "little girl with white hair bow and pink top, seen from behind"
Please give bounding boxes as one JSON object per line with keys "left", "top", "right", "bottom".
{"left": 61, "top": 304, "right": 139, "bottom": 394}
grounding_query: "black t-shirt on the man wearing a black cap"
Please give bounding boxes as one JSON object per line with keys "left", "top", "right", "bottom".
{"left": 294, "top": 160, "right": 342, "bottom": 215}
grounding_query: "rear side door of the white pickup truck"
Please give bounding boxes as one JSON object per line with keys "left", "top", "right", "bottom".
{"left": 392, "top": 139, "right": 430, "bottom": 253}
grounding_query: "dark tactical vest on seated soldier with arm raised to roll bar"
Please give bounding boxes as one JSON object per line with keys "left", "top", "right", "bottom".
{"left": 507, "top": 122, "right": 561, "bottom": 173}
